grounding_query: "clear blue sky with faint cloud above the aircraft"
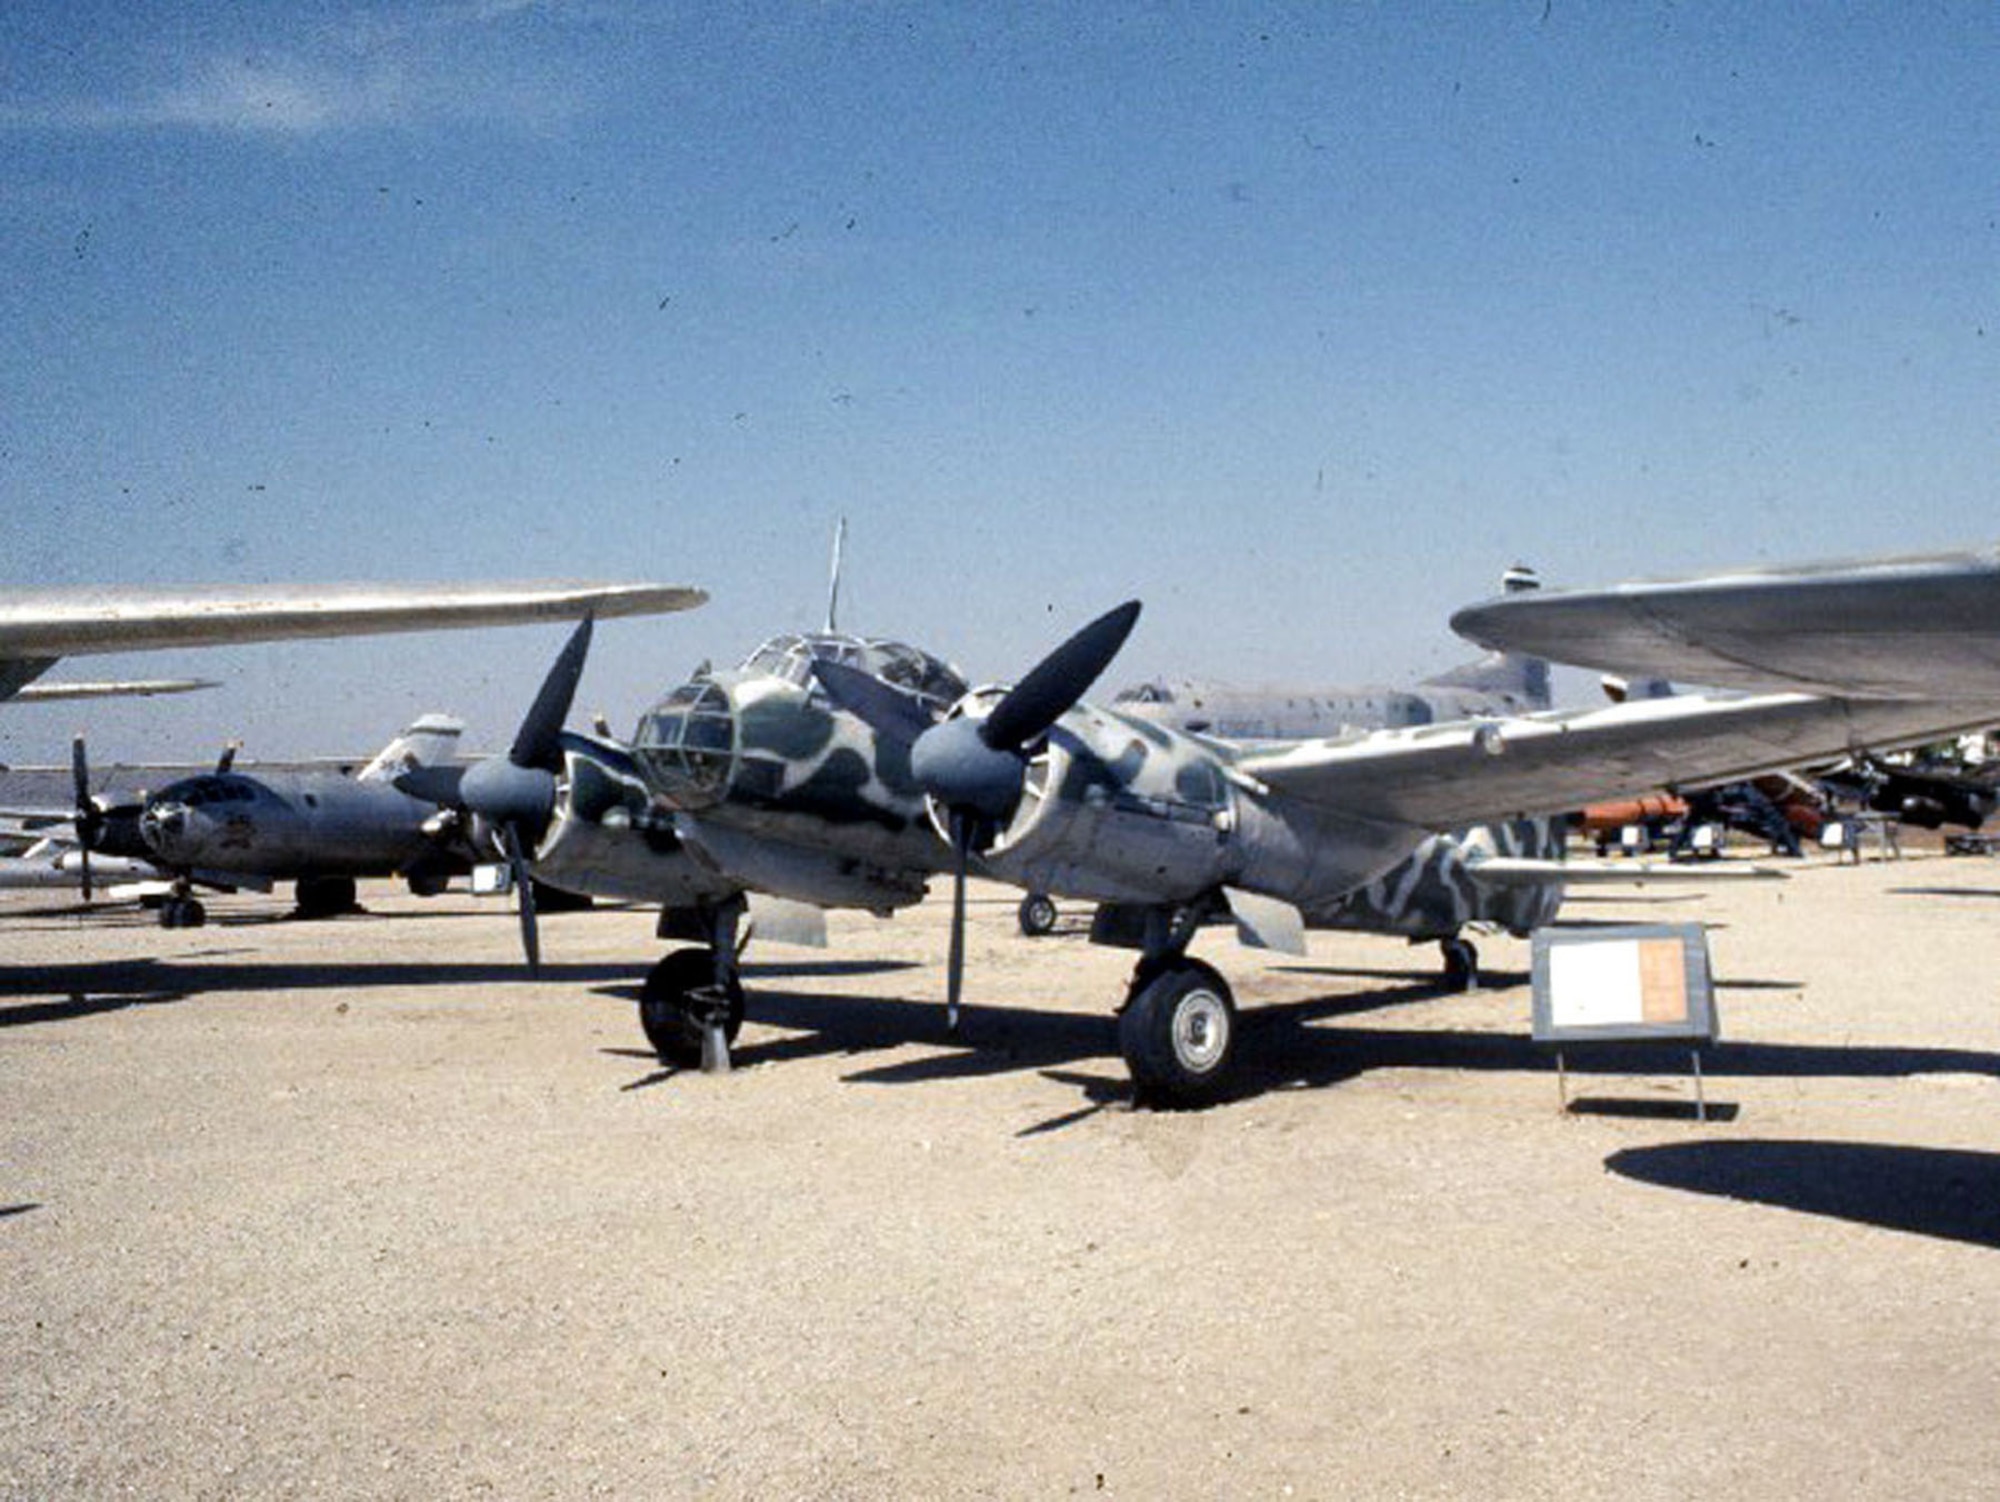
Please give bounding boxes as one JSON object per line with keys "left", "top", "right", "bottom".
{"left": 0, "top": 0, "right": 2000, "bottom": 762}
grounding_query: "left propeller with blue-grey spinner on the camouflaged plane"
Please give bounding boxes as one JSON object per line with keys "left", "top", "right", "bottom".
{"left": 396, "top": 616, "right": 592, "bottom": 974}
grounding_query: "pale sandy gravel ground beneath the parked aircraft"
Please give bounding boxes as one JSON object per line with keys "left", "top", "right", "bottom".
{"left": 0, "top": 858, "right": 2000, "bottom": 1498}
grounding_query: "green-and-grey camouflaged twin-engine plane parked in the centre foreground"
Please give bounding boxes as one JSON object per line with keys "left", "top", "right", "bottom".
{"left": 458, "top": 580, "right": 2000, "bottom": 1104}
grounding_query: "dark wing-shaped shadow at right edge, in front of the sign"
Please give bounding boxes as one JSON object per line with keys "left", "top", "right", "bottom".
{"left": 1604, "top": 1140, "right": 2000, "bottom": 1248}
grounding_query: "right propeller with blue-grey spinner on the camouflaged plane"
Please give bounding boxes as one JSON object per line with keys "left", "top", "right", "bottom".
{"left": 812, "top": 600, "right": 1140, "bottom": 1032}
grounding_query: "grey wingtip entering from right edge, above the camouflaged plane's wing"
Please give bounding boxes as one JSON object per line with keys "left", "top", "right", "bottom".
{"left": 1452, "top": 548, "right": 2000, "bottom": 700}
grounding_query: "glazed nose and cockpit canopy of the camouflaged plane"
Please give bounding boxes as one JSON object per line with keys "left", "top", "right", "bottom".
{"left": 632, "top": 634, "right": 966, "bottom": 810}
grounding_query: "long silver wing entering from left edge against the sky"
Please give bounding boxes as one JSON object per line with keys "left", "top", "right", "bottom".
{"left": 0, "top": 580, "right": 708, "bottom": 700}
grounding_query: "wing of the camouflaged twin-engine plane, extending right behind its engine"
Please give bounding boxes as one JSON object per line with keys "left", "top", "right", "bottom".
{"left": 1232, "top": 694, "right": 2000, "bottom": 830}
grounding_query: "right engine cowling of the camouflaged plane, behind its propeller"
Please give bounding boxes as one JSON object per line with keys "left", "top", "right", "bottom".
{"left": 930, "top": 694, "right": 1236, "bottom": 904}
